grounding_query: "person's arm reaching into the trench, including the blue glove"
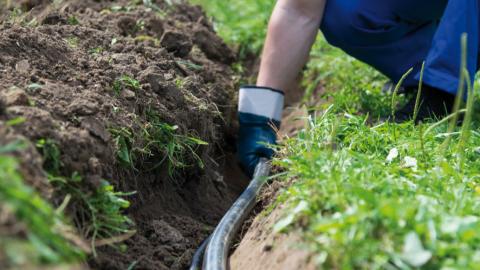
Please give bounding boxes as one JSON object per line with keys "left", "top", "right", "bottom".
{"left": 237, "top": 0, "right": 326, "bottom": 176}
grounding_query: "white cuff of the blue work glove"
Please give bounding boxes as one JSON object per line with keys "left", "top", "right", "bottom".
{"left": 238, "top": 85, "right": 284, "bottom": 123}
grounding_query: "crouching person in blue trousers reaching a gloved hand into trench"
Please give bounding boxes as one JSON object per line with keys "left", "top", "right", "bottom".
{"left": 238, "top": 0, "right": 480, "bottom": 176}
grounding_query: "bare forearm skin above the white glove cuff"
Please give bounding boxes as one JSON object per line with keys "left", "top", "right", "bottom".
{"left": 257, "top": 0, "right": 326, "bottom": 91}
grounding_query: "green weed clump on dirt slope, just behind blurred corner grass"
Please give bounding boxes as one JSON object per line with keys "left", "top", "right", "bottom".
{"left": 36, "top": 139, "right": 134, "bottom": 255}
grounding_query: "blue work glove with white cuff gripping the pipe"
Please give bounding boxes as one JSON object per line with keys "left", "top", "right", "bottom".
{"left": 237, "top": 86, "right": 284, "bottom": 177}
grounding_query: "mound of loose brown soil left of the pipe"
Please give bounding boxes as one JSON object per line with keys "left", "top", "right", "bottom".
{"left": 0, "top": 0, "right": 245, "bottom": 269}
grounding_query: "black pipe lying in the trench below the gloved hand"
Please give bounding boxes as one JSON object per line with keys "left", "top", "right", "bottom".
{"left": 190, "top": 158, "right": 270, "bottom": 270}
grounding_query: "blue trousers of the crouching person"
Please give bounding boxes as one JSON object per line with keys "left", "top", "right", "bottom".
{"left": 321, "top": 0, "right": 480, "bottom": 94}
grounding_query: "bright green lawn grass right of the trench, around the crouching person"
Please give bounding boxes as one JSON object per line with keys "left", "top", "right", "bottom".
{"left": 194, "top": 1, "right": 480, "bottom": 269}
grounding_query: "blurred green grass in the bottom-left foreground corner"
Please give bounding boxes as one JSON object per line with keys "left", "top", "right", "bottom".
{"left": 0, "top": 142, "right": 85, "bottom": 267}
